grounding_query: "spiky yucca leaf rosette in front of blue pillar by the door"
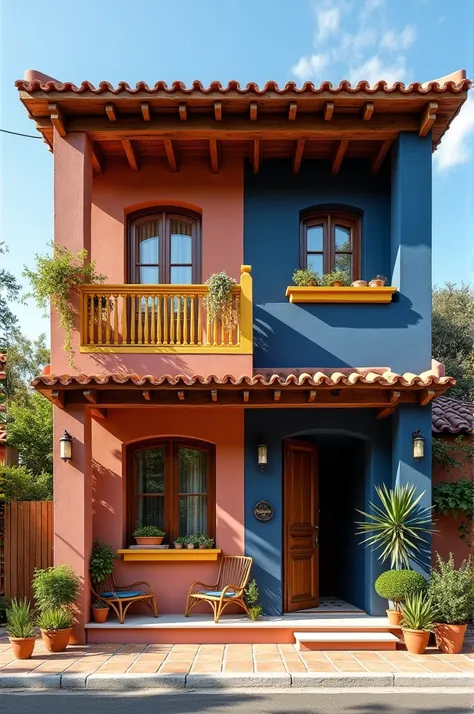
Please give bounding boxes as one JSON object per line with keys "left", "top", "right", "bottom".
{"left": 356, "top": 484, "right": 434, "bottom": 570}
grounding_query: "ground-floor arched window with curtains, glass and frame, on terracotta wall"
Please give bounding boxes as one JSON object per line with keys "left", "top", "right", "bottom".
{"left": 127, "top": 438, "right": 216, "bottom": 543}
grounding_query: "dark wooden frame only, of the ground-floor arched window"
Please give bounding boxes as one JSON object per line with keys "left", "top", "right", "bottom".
{"left": 126, "top": 437, "right": 216, "bottom": 544}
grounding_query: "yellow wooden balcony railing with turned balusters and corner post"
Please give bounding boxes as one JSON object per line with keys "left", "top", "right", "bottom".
{"left": 80, "top": 265, "right": 253, "bottom": 354}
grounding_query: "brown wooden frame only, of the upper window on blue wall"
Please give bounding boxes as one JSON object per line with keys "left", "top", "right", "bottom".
{"left": 300, "top": 211, "right": 361, "bottom": 280}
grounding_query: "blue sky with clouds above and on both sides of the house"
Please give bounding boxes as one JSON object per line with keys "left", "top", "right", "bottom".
{"left": 0, "top": 0, "right": 474, "bottom": 336}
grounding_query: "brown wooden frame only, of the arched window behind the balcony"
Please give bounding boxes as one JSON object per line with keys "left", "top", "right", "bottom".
{"left": 127, "top": 206, "right": 202, "bottom": 285}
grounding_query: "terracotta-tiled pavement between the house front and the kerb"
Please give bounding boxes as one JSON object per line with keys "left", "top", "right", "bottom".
{"left": 0, "top": 637, "right": 474, "bottom": 677}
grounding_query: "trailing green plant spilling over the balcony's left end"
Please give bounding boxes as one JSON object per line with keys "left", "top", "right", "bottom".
{"left": 23, "top": 242, "right": 107, "bottom": 366}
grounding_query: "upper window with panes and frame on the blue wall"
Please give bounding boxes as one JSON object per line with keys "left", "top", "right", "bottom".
{"left": 300, "top": 212, "right": 360, "bottom": 282}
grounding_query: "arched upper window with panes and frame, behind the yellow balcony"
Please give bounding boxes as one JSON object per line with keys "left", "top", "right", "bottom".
{"left": 129, "top": 209, "right": 201, "bottom": 285}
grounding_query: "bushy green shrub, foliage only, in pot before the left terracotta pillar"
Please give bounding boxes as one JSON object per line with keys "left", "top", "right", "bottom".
{"left": 32, "top": 565, "right": 81, "bottom": 612}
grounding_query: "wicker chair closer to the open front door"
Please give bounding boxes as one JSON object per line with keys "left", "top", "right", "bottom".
{"left": 184, "top": 555, "right": 252, "bottom": 622}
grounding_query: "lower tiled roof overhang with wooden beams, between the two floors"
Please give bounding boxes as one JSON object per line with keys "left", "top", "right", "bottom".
{"left": 33, "top": 370, "right": 455, "bottom": 418}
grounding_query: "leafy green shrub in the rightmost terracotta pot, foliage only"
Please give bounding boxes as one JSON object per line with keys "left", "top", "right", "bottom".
{"left": 428, "top": 553, "right": 473, "bottom": 625}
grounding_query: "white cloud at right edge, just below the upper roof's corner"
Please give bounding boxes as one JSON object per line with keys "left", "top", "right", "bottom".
{"left": 434, "top": 94, "right": 474, "bottom": 171}
